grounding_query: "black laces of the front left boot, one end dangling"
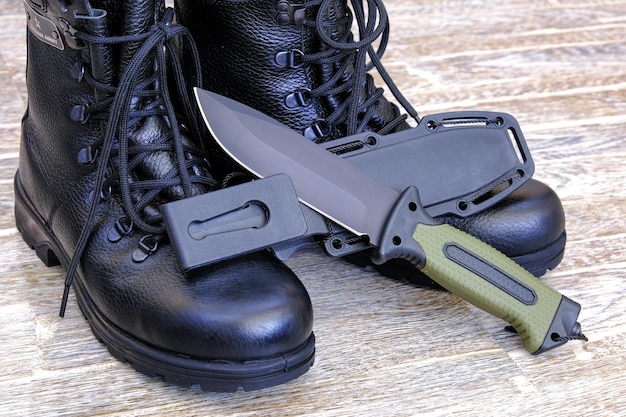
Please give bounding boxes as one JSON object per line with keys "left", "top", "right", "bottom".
{"left": 59, "top": 9, "right": 216, "bottom": 317}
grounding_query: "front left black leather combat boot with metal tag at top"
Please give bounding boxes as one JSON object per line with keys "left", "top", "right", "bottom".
{"left": 15, "top": 0, "right": 314, "bottom": 391}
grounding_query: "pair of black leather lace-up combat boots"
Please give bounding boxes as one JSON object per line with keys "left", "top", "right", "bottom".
{"left": 15, "top": 0, "right": 565, "bottom": 391}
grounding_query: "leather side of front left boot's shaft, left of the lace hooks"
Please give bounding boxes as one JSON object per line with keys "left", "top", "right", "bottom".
{"left": 19, "top": 1, "right": 115, "bottom": 216}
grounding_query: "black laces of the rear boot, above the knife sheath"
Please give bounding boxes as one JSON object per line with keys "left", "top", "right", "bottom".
{"left": 302, "top": 0, "right": 419, "bottom": 140}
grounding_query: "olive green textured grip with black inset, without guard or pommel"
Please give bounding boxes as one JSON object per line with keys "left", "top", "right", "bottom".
{"left": 413, "top": 224, "right": 562, "bottom": 353}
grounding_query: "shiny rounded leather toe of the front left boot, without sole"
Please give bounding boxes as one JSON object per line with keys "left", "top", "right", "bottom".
{"left": 83, "top": 242, "right": 313, "bottom": 362}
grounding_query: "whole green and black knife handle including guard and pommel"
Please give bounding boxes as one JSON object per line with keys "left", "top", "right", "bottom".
{"left": 373, "top": 187, "right": 580, "bottom": 353}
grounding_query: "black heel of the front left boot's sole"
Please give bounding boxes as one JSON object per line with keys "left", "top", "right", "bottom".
{"left": 15, "top": 175, "right": 60, "bottom": 266}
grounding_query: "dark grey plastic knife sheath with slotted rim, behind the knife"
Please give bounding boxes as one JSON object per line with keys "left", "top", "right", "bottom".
{"left": 312, "top": 111, "right": 535, "bottom": 258}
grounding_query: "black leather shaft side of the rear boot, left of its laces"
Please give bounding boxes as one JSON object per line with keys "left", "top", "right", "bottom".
{"left": 176, "top": 0, "right": 324, "bottom": 136}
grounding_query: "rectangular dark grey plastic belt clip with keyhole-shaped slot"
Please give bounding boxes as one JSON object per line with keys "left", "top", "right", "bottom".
{"left": 161, "top": 171, "right": 307, "bottom": 272}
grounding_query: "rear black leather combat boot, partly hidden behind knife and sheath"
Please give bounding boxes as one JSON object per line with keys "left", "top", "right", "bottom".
{"left": 176, "top": 0, "right": 565, "bottom": 285}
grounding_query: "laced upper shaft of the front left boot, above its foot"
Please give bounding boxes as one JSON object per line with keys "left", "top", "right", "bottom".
{"left": 19, "top": 0, "right": 212, "bottom": 253}
